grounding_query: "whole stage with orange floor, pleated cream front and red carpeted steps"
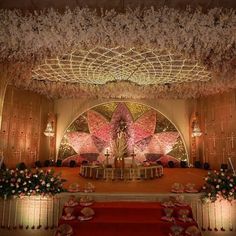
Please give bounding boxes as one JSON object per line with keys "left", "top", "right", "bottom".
{"left": 0, "top": 167, "right": 236, "bottom": 235}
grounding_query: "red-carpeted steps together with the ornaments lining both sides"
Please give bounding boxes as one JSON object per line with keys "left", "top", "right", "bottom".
{"left": 56, "top": 200, "right": 200, "bottom": 236}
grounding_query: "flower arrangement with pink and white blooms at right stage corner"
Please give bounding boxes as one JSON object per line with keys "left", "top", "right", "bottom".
{"left": 203, "top": 169, "right": 236, "bottom": 202}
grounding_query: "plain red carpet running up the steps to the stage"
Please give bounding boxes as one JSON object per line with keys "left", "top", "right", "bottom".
{"left": 60, "top": 202, "right": 199, "bottom": 236}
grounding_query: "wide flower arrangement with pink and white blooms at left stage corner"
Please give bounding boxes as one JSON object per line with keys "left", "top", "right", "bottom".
{"left": 0, "top": 169, "right": 65, "bottom": 198}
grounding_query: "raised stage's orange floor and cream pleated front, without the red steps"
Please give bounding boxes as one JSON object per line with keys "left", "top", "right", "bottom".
{"left": 0, "top": 167, "right": 236, "bottom": 236}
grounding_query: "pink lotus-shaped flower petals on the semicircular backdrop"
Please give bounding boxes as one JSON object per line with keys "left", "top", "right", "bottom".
{"left": 61, "top": 103, "right": 186, "bottom": 161}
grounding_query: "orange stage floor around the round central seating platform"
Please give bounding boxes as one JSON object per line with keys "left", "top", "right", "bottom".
{"left": 53, "top": 167, "right": 207, "bottom": 194}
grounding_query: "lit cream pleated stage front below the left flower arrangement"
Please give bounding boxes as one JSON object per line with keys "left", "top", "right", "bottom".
{"left": 0, "top": 196, "right": 62, "bottom": 229}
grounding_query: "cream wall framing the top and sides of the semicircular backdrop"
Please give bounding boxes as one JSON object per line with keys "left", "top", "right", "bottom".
{"left": 54, "top": 98, "right": 190, "bottom": 162}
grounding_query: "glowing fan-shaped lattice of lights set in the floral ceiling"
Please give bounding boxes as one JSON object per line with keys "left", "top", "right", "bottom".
{"left": 33, "top": 47, "right": 210, "bottom": 85}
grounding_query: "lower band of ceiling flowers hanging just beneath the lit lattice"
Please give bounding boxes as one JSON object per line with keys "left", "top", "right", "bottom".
{"left": 12, "top": 77, "right": 236, "bottom": 99}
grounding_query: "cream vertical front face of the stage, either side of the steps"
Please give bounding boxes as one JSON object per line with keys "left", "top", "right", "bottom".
{"left": 0, "top": 193, "right": 236, "bottom": 232}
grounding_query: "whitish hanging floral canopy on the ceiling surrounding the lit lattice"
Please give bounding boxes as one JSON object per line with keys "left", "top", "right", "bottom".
{"left": 0, "top": 7, "right": 236, "bottom": 98}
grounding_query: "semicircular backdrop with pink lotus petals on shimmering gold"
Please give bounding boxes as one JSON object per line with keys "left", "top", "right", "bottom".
{"left": 59, "top": 102, "right": 187, "bottom": 165}
